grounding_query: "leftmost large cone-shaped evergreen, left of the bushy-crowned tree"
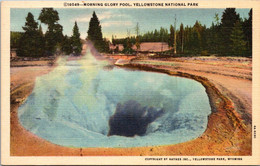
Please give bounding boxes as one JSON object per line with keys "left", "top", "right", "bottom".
{"left": 17, "top": 12, "right": 42, "bottom": 57}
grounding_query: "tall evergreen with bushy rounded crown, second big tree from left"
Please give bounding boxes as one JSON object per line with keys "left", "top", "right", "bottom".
{"left": 38, "top": 8, "right": 63, "bottom": 55}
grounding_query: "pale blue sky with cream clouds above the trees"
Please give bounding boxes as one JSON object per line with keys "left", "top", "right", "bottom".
{"left": 11, "top": 8, "right": 250, "bottom": 39}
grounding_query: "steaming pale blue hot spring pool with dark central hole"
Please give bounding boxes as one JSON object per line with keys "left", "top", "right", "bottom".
{"left": 18, "top": 52, "right": 211, "bottom": 147}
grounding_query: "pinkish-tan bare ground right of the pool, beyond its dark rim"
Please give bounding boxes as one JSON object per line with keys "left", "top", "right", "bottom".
{"left": 132, "top": 58, "right": 252, "bottom": 123}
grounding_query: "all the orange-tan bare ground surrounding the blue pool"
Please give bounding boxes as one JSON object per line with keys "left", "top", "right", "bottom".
{"left": 10, "top": 47, "right": 252, "bottom": 156}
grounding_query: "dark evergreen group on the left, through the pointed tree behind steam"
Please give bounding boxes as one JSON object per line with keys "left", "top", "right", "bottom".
{"left": 11, "top": 8, "right": 105, "bottom": 57}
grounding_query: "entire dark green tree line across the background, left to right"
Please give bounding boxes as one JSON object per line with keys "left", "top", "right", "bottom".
{"left": 11, "top": 8, "right": 252, "bottom": 57}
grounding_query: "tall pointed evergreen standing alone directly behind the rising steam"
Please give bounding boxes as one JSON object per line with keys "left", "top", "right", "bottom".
{"left": 87, "top": 11, "right": 104, "bottom": 52}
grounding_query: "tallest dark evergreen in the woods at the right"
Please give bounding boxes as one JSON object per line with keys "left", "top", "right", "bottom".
{"left": 220, "top": 8, "right": 240, "bottom": 56}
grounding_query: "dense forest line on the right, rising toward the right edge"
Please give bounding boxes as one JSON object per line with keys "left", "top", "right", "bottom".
{"left": 112, "top": 8, "right": 252, "bottom": 57}
